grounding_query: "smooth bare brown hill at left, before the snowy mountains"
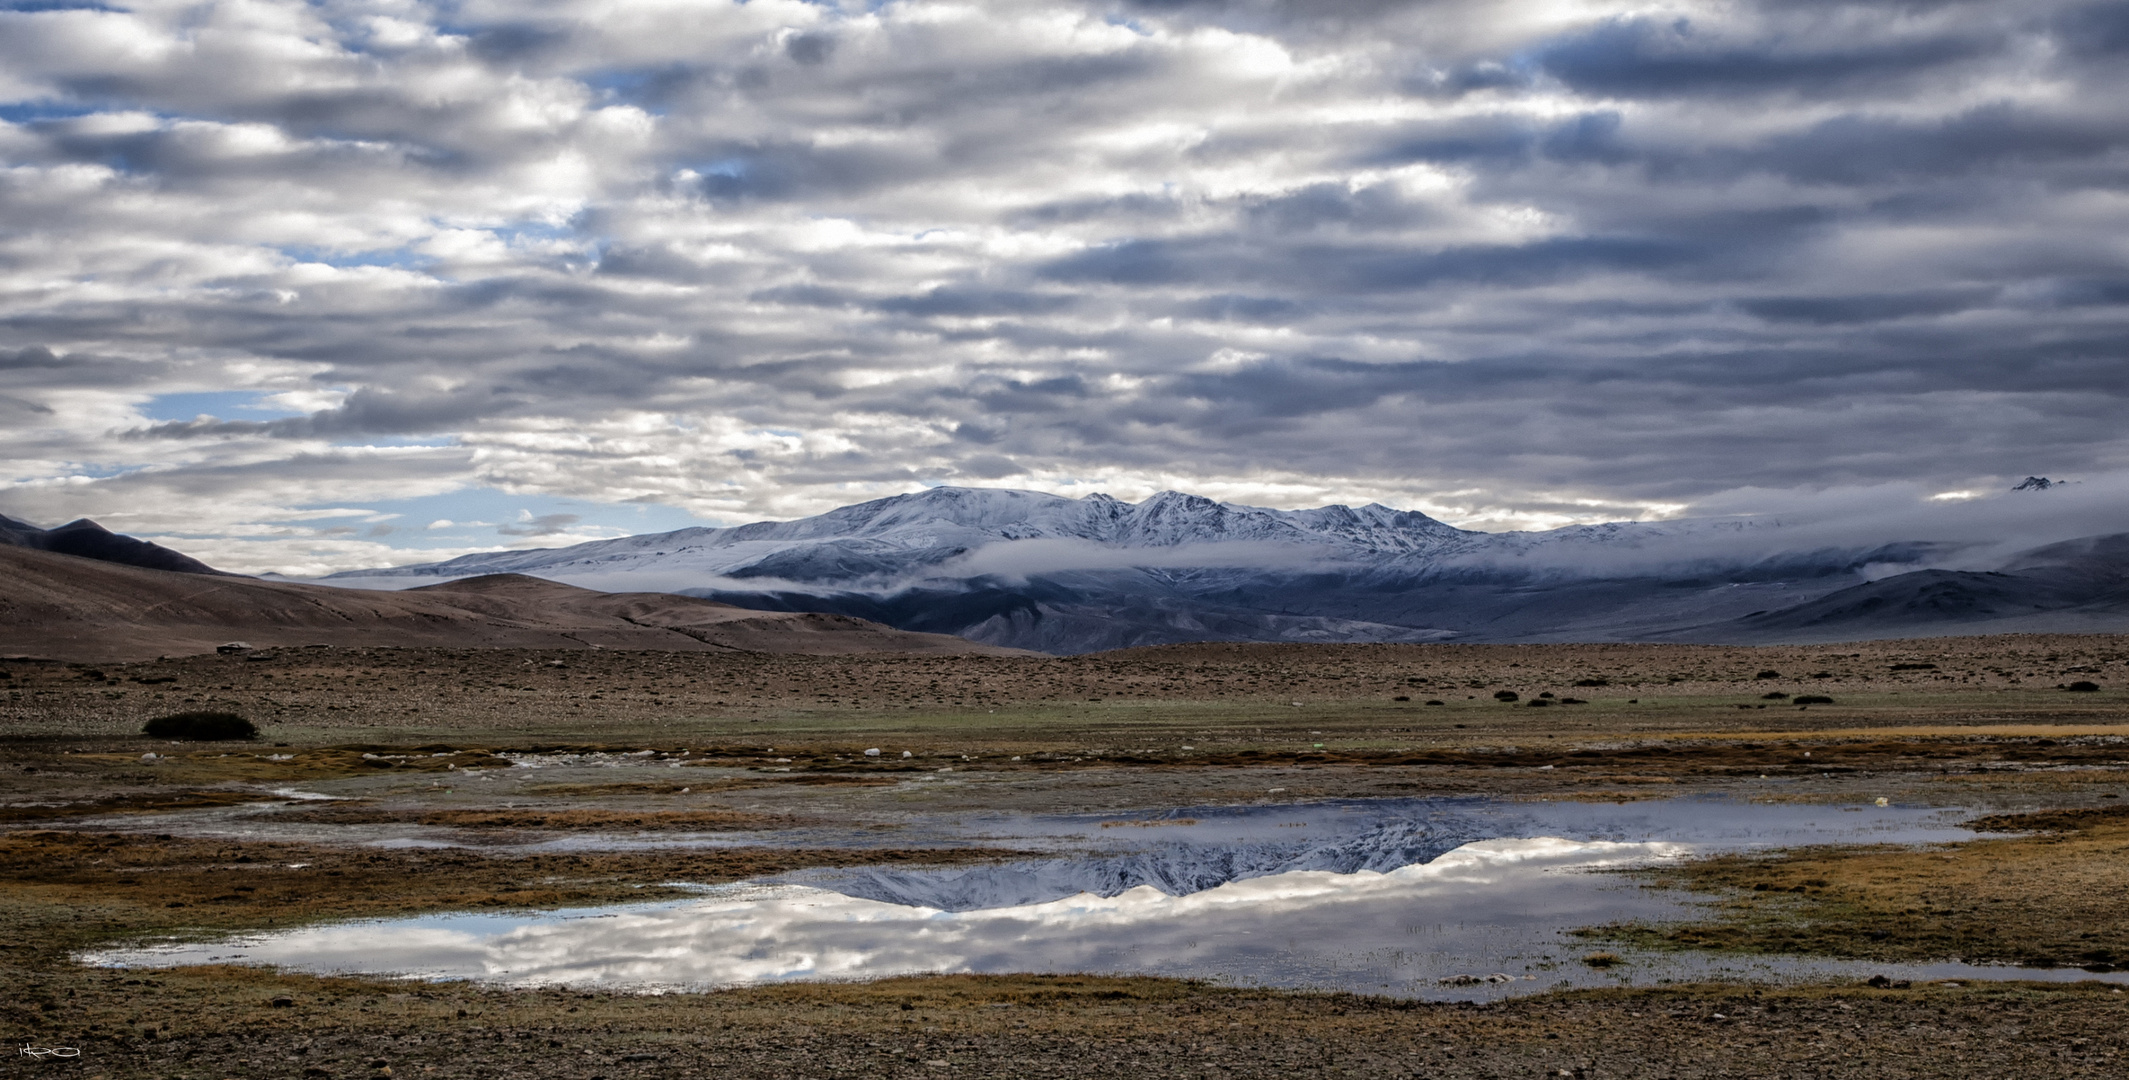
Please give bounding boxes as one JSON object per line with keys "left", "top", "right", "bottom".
{"left": 0, "top": 547, "right": 1016, "bottom": 662}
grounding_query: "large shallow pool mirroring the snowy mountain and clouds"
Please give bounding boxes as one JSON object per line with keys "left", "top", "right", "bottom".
{"left": 83, "top": 799, "right": 2129, "bottom": 999}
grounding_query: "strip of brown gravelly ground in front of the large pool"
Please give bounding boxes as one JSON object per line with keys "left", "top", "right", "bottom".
{"left": 11, "top": 973, "right": 2129, "bottom": 1080}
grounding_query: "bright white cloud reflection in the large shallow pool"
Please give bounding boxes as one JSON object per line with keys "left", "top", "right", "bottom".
{"left": 92, "top": 837, "right": 1680, "bottom": 988}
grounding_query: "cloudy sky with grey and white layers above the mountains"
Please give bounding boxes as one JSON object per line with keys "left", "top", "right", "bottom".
{"left": 0, "top": 0, "right": 2129, "bottom": 573}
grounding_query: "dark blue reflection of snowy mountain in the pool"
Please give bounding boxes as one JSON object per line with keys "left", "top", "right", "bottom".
{"left": 794, "top": 814, "right": 1516, "bottom": 912}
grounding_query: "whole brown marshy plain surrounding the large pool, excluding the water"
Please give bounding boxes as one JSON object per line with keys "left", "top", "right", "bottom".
{"left": 0, "top": 637, "right": 2129, "bottom": 1078}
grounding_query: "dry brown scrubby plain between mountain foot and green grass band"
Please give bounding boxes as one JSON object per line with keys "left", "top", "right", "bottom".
{"left": 0, "top": 635, "right": 2129, "bottom": 741}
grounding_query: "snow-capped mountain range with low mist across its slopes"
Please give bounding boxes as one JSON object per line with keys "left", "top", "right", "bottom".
{"left": 324, "top": 488, "right": 2112, "bottom": 652}
